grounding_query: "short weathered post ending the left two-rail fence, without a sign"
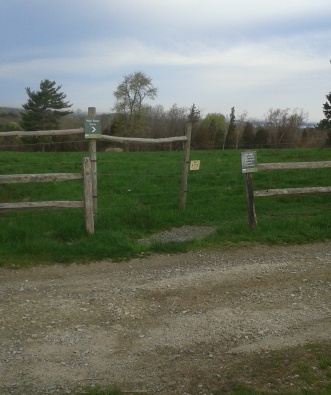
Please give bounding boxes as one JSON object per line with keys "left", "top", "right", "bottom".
{"left": 83, "top": 158, "right": 94, "bottom": 234}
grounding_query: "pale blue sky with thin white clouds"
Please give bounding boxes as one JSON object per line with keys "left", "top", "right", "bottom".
{"left": 0, "top": 0, "right": 331, "bottom": 122}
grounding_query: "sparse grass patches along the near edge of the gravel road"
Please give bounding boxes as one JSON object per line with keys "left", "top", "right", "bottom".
{"left": 68, "top": 343, "right": 331, "bottom": 395}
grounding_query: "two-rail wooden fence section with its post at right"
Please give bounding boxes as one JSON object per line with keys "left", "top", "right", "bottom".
{"left": 245, "top": 161, "right": 331, "bottom": 228}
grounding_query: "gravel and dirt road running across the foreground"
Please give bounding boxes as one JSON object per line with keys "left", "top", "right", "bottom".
{"left": 0, "top": 243, "right": 331, "bottom": 394}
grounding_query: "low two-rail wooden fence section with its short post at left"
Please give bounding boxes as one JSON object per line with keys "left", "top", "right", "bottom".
{"left": 0, "top": 158, "right": 94, "bottom": 234}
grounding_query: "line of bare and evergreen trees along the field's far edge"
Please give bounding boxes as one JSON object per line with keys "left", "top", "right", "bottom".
{"left": 0, "top": 67, "right": 331, "bottom": 151}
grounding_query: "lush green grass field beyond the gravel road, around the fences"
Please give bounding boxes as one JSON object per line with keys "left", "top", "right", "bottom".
{"left": 0, "top": 149, "right": 331, "bottom": 267}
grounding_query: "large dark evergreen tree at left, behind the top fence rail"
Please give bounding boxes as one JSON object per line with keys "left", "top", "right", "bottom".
{"left": 21, "top": 79, "right": 73, "bottom": 131}
